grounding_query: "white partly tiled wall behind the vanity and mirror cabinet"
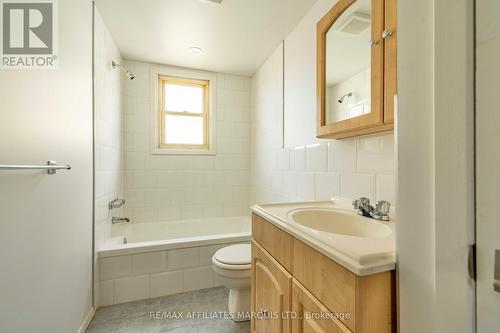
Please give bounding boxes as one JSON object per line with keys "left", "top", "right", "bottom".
{"left": 251, "top": 1, "right": 395, "bottom": 209}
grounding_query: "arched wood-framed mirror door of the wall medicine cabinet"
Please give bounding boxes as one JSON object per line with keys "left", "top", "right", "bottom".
{"left": 316, "top": 0, "right": 392, "bottom": 138}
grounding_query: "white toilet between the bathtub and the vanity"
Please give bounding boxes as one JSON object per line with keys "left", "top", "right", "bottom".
{"left": 212, "top": 244, "right": 252, "bottom": 321}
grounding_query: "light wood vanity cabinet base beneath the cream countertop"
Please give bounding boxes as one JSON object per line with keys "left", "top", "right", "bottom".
{"left": 251, "top": 214, "right": 396, "bottom": 333}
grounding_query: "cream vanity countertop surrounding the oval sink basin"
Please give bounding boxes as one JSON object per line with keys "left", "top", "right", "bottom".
{"left": 252, "top": 200, "right": 396, "bottom": 276}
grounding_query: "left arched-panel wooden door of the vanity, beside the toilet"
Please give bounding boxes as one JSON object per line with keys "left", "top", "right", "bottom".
{"left": 251, "top": 241, "right": 292, "bottom": 333}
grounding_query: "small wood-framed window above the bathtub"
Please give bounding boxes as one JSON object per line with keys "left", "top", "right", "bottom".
{"left": 158, "top": 75, "right": 210, "bottom": 150}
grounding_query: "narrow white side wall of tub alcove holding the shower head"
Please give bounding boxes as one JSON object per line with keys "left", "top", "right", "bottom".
{"left": 94, "top": 8, "right": 125, "bottom": 249}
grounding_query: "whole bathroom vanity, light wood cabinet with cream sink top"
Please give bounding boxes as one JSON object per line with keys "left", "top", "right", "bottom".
{"left": 251, "top": 202, "right": 396, "bottom": 333}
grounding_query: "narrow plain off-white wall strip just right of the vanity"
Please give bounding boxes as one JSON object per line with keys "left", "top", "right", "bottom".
{"left": 397, "top": 0, "right": 436, "bottom": 333}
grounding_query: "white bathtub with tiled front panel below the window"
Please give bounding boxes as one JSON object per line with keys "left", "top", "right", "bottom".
{"left": 97, "top": 216, "right": 251, "bottom": 306}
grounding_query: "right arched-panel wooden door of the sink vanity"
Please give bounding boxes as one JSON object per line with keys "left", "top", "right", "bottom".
{"left": 292, "top": 279, "right": 351, "bottom": 333}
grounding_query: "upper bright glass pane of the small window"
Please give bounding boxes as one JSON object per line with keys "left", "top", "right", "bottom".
{"left": 163, "top": 83, "right": 204, "bottom": 113}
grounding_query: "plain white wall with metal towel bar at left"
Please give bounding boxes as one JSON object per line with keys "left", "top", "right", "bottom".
{"left": 0, "top": 0, "right": 93, "bottom": 333}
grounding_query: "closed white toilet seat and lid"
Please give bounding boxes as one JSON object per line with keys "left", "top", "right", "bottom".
{"left": 212, "top": 244, "right": 252, "bottom": 270}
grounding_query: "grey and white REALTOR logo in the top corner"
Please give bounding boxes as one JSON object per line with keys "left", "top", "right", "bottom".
{"left": 1, "top": 0, "right": 57, "bottom": 69}
